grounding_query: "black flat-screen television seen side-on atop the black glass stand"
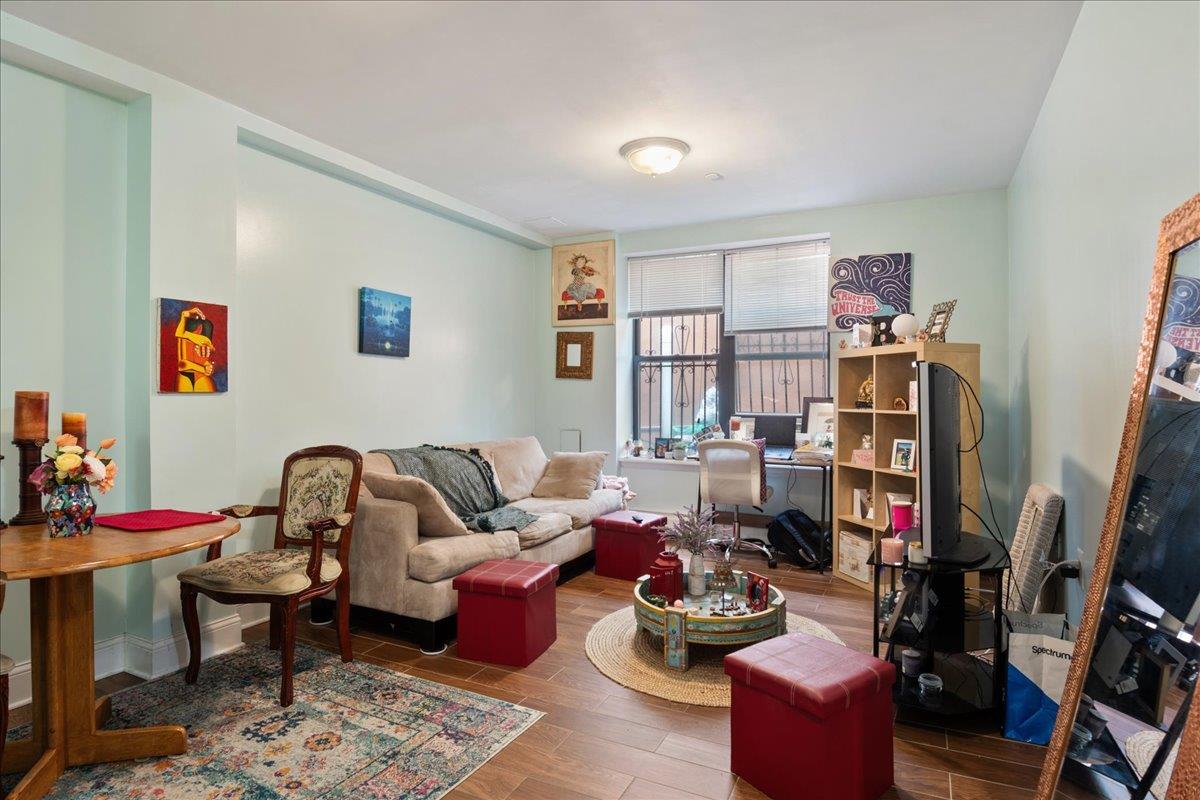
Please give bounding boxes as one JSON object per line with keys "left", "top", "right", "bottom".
{"left": 917, "top": 361, "right": 988, "bottom": 565}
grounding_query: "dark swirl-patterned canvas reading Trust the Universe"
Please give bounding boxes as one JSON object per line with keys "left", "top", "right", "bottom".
{"left": 829, "top": 253, "right": 912, "bottom": 331}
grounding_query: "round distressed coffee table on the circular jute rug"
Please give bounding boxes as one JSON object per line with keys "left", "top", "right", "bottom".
{"left": 634, "top": 571, "right": 787, "bottom": 672}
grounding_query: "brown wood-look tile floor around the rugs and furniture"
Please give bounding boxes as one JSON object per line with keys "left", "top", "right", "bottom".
{"left": 2, "top": 555, "right": 1070, "bottom": 800}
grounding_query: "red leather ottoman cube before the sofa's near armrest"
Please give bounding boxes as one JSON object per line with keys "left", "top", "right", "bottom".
{"left": 454, "top": 559, "right": 558, "bottom": 667}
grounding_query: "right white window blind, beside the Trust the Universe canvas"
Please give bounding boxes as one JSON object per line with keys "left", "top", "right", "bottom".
{"left": 725, "top": 239, "right": 829, "bottom": 333}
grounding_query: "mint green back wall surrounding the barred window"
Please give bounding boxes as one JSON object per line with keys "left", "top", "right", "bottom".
{"left": 544, "top": 190, "right": 1010, "bottom": 531}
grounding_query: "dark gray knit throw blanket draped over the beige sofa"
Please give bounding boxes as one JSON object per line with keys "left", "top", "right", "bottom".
{"left": 371, "top": 445, "right": 538, "bottom": 534}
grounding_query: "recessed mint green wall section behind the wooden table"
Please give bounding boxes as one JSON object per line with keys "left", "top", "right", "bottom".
{"left": 0, "top": 64, "right": 130, "bottom": 660}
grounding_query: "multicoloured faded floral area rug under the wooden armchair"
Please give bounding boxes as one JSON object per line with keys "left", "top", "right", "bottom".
{"left": 4, "top": 643, "right": 541, "bottom": 800}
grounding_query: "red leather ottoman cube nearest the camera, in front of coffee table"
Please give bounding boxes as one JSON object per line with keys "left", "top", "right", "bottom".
{"left": 725, "top": 633, "right": 895, "bottom": 800}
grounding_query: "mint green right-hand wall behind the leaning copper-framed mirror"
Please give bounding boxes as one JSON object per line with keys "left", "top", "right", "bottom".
{"left": 1008, "top": 2, "right": 1200, "bottom": 619}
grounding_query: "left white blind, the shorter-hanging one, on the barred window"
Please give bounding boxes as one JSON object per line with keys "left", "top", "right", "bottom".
{"left": 629, "top": 251, "right": 724, "bottom": 317}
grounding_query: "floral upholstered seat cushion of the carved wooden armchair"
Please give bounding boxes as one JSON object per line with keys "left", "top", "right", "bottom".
{"left": 179, "top": 549, "right": 342, "bottom": 595}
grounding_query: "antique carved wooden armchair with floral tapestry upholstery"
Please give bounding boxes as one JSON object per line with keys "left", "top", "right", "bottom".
{"left": 179, "top": 445, "right": 362, "bottom": 705}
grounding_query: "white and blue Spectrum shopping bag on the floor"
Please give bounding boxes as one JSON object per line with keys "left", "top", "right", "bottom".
{"left": 1004, "top": 633, "right": 1075, "bottom": 745}
